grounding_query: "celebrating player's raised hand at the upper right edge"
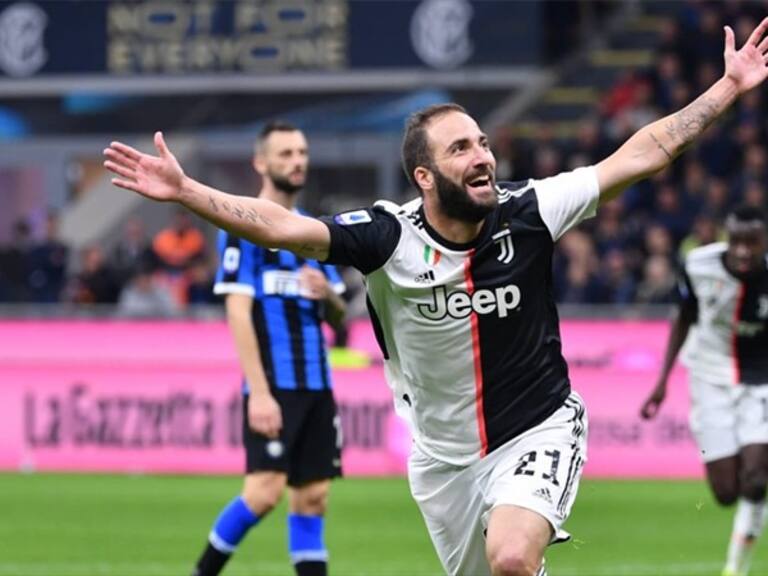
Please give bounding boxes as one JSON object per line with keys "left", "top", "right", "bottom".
{"left": 725, "top": 17, "right": 768, "bottom": 93}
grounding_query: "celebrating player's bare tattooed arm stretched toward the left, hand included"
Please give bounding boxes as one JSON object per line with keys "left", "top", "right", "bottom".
{"left": 104, "top": 132, "right": 330, "bottom": 260}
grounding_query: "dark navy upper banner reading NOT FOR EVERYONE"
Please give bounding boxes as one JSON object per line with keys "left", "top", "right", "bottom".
{"left": 0, "top": 0, "right": 543, "bottom": 79}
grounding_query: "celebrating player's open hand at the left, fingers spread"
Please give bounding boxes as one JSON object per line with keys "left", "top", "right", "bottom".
{"left": 104, "top": 132, "right": 184, "bottom": 202}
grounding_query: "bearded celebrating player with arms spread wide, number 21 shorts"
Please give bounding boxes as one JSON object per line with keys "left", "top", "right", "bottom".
{"left": 104, "top": 18, "right": 768, "bottom": 576}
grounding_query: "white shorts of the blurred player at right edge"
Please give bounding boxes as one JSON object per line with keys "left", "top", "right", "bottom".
{"left": 690, "top": 380, "right": 768, "bottom": 462}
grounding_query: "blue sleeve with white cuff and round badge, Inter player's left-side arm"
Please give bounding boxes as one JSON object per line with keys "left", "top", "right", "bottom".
{"left": 213, "top": 230, "right": 258, "bottom": 296}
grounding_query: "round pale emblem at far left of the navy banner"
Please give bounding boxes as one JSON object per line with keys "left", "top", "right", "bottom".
{"left": 0, "top": 2, "right": 48, "bottom": 76}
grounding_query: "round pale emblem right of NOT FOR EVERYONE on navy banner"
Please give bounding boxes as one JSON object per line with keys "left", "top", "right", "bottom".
{"left": 411, "top": 0, "right": 473, "bottom": 69}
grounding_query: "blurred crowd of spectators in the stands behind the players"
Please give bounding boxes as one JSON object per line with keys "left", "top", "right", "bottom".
{"left": 0, "top": 2, "right": 768, "bottom": 316}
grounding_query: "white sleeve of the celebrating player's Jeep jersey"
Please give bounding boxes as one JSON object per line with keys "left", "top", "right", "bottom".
{"left": 533, "top": 166, "right": 600, "bottom": 241}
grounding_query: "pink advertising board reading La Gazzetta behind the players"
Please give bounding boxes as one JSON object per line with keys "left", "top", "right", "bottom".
{"left": 0, "top": 321, "right": 702, "bottom": 477}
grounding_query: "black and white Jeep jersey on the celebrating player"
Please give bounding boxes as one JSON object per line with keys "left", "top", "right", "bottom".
{"left": 324, "top": 167, "right": 599, "bottom": 465}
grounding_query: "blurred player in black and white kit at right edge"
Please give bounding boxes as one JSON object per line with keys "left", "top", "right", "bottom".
{"left": 641, "top": 205, "right": 768, "bottom": 576}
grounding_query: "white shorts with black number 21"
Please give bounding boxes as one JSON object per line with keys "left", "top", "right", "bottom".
{"left": 408, "top": 392, "right": 587, "bottom": 576}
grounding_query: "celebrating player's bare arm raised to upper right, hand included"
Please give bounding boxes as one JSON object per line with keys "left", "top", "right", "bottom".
{"left": 597, "top": 17, "right": 768, "bottom": 202}
